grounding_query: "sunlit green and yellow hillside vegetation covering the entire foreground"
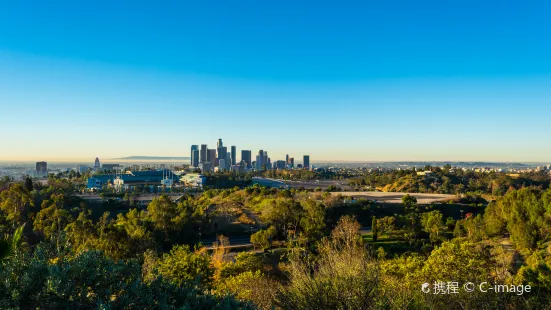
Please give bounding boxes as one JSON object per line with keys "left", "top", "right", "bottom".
{"left": 0, "top": 176, "right": 551, "bottom": 309}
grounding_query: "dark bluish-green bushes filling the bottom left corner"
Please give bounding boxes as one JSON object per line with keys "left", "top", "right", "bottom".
{"left": 0, "top": 245, "right": 251, "bottom": 309}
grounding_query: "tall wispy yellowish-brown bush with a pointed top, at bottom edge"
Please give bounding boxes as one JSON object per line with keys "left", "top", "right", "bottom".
{"left": 277, "top": 217, "right": 379, "bottom": 309}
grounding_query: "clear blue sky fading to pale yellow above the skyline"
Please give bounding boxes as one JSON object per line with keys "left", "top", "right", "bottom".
{"left": 0, "top": 0, "right": 551, "bottom": 162}
